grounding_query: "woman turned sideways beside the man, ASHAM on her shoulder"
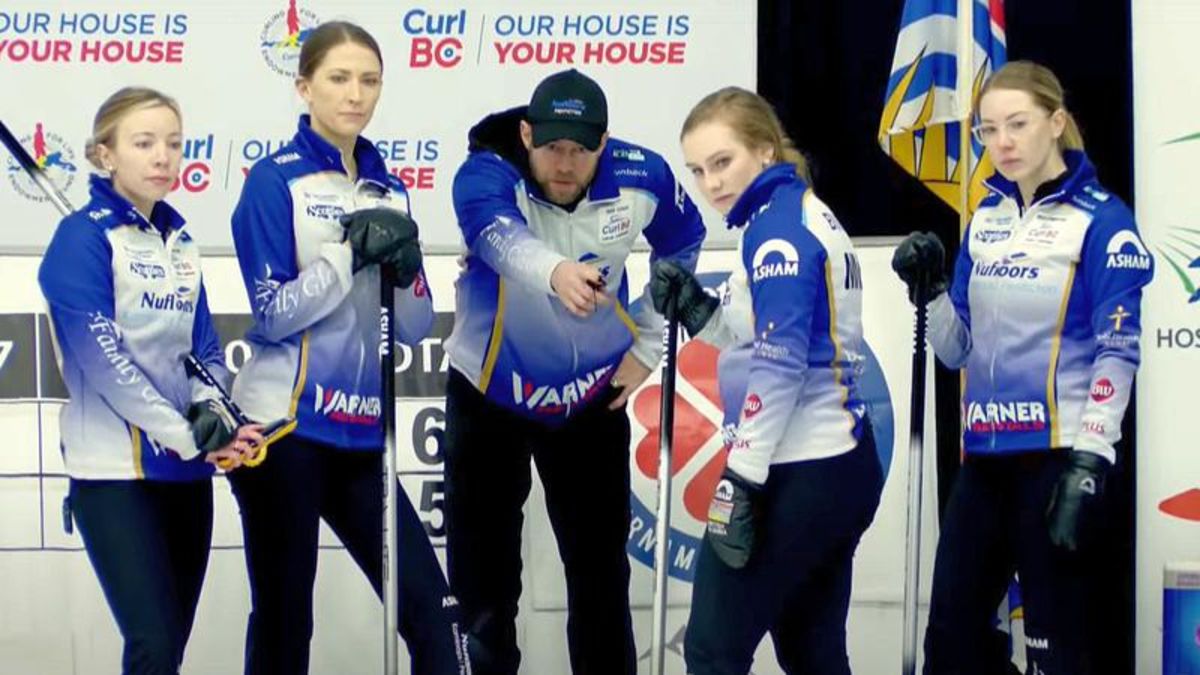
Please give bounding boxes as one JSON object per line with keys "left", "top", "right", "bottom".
{"left": 650, "top": 86, "right": 883, "bottom": 675}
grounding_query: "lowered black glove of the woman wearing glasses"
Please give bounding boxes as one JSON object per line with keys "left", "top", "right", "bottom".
{"left": 1046, "top": 450, "right": 1111, "bottom": 551}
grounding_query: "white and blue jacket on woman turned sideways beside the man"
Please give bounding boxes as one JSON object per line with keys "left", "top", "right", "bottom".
{"left": 696, "top": 163, "right": 866, "bottom": 484}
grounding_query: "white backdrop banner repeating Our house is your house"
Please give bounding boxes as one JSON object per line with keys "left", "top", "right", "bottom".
{"left": 0, "top": 0, "right": 757, "bottom": 250}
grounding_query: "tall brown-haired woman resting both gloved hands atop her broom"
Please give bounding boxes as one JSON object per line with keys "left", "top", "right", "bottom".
{"left": 232, "top": 22, "right": 462, "bottom": 675}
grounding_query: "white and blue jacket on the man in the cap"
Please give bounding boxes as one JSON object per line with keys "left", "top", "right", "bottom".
{"left": 446, "top": 108, "right": 704, "bottom": 425}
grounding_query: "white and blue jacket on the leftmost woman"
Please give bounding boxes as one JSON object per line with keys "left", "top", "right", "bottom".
{"left": 37, "top": 175, "right": 228, "bottom": 480}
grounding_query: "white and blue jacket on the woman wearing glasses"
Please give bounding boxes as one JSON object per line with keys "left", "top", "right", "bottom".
{"left": 930, "top": 151, "right": 1154, "bottom": 461}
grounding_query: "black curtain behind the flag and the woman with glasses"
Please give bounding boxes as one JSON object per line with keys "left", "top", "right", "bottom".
{"left": 758, "top": 0, "right": 1135, "bottom": 675}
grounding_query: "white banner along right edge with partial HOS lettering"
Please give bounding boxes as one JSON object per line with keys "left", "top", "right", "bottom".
{"left": 1133, "top": 0, "right": 1200, "bottom": 675}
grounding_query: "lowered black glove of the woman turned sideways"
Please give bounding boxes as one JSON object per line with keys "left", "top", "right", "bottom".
{"left": 707, "top": 468, "right": 762, "bottom": 569}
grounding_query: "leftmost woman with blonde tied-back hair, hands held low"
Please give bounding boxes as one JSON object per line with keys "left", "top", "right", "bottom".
{"left": 37, "top": 86, "right": 263, "bottom": 674}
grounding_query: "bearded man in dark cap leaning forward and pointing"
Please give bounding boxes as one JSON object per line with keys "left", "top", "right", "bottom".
{"left": 445, "top": 68, "right": 704, "bottom": 675}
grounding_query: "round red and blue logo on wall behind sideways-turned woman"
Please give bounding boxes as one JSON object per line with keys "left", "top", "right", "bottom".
{"left": 625, "top": 274, "right": 894, "bottom": 583}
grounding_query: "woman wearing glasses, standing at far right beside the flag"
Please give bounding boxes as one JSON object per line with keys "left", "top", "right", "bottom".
{"left": 892, "top": 61, "right": 1153, "bottom": 675}
